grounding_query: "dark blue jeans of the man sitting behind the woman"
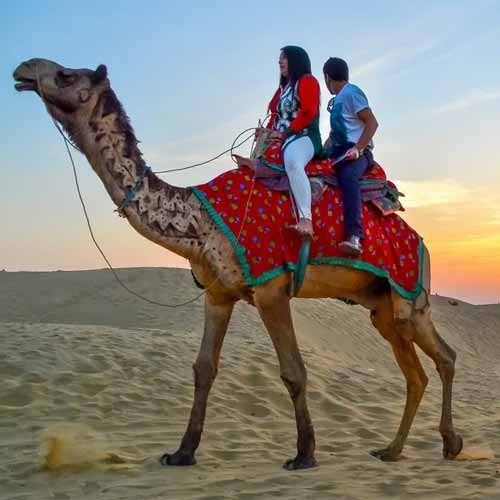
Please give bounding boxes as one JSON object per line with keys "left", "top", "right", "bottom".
{"left": 336, "top": 149, "right": 373, "bottom": 240}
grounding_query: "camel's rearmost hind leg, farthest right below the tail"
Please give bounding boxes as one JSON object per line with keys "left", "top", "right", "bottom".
{"left": 411, "top": 305, "right": 463, "bottom": 459}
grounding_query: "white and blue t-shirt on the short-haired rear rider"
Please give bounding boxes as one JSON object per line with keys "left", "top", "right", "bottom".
{"left": 330, "top": 83, "right": 373, "bottom": 148}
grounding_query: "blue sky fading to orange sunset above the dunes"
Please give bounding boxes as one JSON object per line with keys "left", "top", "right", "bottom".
{"left": 0, "top": 0, "right": 500, "bottom": 303}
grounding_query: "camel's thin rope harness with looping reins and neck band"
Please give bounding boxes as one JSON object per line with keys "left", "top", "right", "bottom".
{"left": 35, "top": 66, "right": 260, "bottom": 308}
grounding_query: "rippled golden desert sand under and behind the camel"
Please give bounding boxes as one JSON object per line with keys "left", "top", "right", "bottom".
{"left": 0, "top": 269, "right": 500, "bottom": 500}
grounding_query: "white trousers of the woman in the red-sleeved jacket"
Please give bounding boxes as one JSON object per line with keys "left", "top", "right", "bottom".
{"left": 283, "top": 136, "right": 314, "bottom": 219}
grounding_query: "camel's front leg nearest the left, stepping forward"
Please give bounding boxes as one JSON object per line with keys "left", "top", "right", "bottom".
{"left": 160, "top": 293, "right": 234, "bottom": 465}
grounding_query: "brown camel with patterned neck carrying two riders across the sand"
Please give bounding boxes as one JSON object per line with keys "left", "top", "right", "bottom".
{"left": 13, "top": 59, "right": 463, "bottom": 470}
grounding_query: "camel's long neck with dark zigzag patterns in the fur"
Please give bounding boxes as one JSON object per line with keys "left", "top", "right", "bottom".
{"left": 74, "top": 90, "right": 202, "bottom": 259}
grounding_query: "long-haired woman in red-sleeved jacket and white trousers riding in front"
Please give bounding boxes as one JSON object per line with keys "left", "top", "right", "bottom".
{"left": 236, "top": 45, "right": 321, "bottom": 237}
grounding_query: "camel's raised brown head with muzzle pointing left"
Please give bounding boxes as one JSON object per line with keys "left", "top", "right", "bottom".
{"left": 13, "top": 59, "right": 110, "bottom": 129}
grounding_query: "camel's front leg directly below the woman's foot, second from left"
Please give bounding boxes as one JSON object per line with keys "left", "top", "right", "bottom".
{"left": 255, "top": 289, "right": 316, "bottom": 470}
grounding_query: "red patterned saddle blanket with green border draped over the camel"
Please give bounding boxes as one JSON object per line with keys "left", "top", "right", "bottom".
{"left": 193, "top": 168, "right": 423, "bottom": 300}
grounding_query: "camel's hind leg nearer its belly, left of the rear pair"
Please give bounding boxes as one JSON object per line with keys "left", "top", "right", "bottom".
{"left": 370, "top": 294, "right": 428, "bottom": 461}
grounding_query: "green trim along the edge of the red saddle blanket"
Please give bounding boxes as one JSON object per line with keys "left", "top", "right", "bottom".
{"left": 192, "top": 187, "right": 424, "bottom": 300}
